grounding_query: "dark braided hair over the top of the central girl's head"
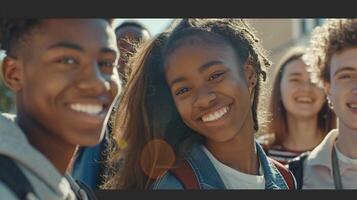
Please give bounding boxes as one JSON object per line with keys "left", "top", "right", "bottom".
{"left": 164, "top": 18, "right": 271, "bottom": 131}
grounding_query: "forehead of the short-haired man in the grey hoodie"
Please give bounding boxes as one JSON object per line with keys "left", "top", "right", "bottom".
{"left": 33, "top": 19, "right": 116, "bottom": 49}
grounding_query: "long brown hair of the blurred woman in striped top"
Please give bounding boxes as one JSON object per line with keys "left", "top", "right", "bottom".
{"left": 264, "top": 46, "right": 336, "bottom": 148}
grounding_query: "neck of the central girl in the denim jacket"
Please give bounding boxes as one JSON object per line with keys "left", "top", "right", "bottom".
{"left": 206, "top": 116, "right": 259, "bottom": 175}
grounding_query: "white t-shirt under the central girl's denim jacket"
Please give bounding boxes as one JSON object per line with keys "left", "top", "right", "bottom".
{"left": 202, "top": 146, "right": 265, "bottom": 189}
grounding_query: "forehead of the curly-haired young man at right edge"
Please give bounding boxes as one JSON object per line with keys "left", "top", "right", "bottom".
{"left": 330, "top": 46, "right": 357, "bottom": 74}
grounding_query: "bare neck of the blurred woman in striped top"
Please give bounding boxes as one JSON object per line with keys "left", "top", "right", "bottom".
{"left": 283, "top": 114, "right": 324, "bottom": 151}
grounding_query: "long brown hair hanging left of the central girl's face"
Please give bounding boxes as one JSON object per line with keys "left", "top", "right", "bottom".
{"left": 102, "top": 33, "right": 196, "bottom": 189}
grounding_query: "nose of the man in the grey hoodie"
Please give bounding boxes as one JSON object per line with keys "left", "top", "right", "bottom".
{"left": 77, "top": 63, "right": 111, "bottom": 95}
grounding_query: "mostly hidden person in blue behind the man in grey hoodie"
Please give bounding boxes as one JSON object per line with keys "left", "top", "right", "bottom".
{"left": 72, "top": 21, "right": 151, "bottom": 189}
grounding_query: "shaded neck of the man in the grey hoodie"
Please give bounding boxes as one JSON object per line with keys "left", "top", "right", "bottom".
{"left": 17, "top": 111, "right": 77, "bottom": 175}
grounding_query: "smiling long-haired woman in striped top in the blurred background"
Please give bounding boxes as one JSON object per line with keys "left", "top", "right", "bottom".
{"left": 259, "top": 47, "right": 336, "bottom": 164}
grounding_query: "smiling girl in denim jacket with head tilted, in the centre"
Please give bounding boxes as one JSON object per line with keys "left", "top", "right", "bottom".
{"left": 106, "top": 19, "right": 294, "bottom": 189}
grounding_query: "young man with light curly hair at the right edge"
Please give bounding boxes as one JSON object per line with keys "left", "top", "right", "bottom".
{"left": 303, "top": 19, "right": 357, "bottom": 189}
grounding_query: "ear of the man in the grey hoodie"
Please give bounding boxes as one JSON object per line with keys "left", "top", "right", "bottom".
{"left": 1, "top": 56, "right": 23, "bottom": 92}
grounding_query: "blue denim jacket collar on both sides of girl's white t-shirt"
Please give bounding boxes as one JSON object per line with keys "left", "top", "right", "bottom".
{"left": 186, "top": 142, "right": 288, "bottom": 189}
